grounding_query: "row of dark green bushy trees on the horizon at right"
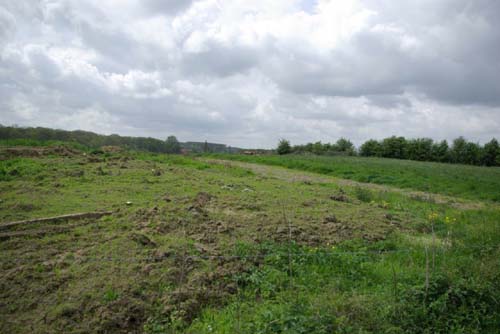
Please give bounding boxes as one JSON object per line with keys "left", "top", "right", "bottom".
{"left": 276, "top": 136, "right": 500, "bottom": 166}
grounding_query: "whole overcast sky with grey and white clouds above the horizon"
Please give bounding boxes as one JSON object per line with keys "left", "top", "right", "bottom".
{"left": 0, "top": 0, "right": 500, "bottom": 148}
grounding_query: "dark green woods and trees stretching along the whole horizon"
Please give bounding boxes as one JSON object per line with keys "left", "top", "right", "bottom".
{"left": 0, "top": 125, "right": 500, "bottom": 166}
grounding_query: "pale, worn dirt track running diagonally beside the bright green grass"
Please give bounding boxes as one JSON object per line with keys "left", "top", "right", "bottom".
{"left": 202, "top": 159, "right": 490, "bottom": 210}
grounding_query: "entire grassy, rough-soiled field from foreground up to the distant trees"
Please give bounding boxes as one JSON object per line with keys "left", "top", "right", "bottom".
{"left": 0, "top": 145, "right": 500, "bottom": 333}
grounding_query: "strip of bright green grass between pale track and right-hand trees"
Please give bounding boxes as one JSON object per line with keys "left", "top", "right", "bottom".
{"left": 210, "top": 154, "right": 500, "bottom": 202}
